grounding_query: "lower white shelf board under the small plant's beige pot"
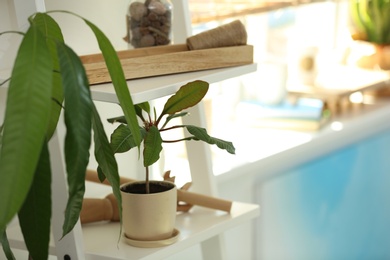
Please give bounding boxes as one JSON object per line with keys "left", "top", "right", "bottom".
{"left": 7, "top": 202, "right": 260, "bottom": 260}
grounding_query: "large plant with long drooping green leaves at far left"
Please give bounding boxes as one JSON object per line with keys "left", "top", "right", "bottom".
{"left": 0, "top": 12, "right": 141, "bottom": 259}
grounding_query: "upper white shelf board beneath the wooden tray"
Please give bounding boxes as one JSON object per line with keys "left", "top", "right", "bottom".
{"left": 91, "top": 63, "right": 257, "bottom": 104}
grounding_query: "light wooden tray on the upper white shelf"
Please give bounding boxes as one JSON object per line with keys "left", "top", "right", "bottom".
{"left": 80, "top": 44, "right": 253, "bottom": 84}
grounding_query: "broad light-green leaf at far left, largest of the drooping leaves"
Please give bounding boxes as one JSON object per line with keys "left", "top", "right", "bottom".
{"left": 0, "top": 25, "right": 53, "bottom": 230}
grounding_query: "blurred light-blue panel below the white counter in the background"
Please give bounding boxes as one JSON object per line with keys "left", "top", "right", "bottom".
{"left": 256, "top": 133, "right": 390, "bottom": 260}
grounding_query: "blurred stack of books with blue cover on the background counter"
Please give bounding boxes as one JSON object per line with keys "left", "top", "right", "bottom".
{"left": 237, "top": 98, "right": 331, "bottom": 131}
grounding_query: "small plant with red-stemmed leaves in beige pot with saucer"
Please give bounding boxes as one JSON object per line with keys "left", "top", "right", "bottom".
{"left": 109, "top": 80, "right": 235, "bottom": 247}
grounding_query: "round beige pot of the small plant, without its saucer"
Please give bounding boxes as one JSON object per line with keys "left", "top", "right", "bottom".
{"left": 121, "top": 181, "right": 177, "bottom": 241}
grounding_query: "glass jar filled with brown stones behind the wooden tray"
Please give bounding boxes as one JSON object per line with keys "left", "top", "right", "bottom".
{"left": 125, "top": 0, "right": 173, "bottom": 48}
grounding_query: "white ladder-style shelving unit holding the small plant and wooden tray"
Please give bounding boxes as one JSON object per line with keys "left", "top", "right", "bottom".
{"left": 3, "top": 0, "right": 259, "bottom": 260}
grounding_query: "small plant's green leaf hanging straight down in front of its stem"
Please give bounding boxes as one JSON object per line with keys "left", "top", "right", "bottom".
{"left": 143, "top": 126, "right": 162, "bottom": 167}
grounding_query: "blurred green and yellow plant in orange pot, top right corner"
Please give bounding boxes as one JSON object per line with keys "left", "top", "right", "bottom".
{"left": 349, "top": 0, "right": 390, "bottom": 70}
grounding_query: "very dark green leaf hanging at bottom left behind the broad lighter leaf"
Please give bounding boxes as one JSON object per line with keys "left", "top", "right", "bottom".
{"left": 18, "top": 143, "right": 51, "bottom": 259}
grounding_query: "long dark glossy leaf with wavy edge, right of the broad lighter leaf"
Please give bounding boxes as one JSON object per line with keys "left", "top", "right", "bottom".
{"left": 57, "top": 42, "right": 92, "bottom": 238}
